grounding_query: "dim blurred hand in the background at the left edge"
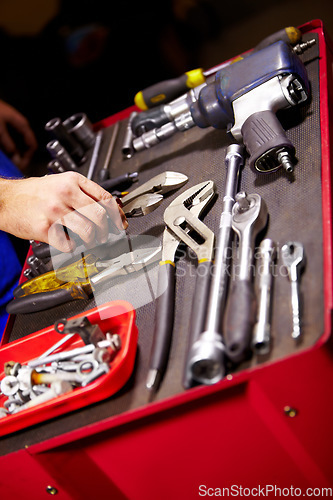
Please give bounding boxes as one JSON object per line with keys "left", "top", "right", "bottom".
{"left": 0, "top": 100, "right": 37, "bottom": 170}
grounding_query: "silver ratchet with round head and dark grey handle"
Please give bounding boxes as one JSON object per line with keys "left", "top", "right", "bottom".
{"left": 224, "top": 191, "right": 268, "bottom": 363}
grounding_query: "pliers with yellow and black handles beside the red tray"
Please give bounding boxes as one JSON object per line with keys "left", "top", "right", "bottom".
{"left": 7, "top": 247, "right": 161, "bottom": 314}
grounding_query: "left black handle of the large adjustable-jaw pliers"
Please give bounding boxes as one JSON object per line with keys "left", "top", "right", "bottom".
{"left": 149, "top": 263, "right": 175, "bottom": 373}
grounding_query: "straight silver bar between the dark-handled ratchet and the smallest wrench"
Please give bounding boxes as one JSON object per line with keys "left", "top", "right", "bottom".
{"left": 252, "top": 238, "right": 277, "bottom": 355}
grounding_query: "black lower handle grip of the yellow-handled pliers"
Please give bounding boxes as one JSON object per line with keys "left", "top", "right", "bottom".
{"left": 6, "top": 288, "right": 84, "bottom": 314}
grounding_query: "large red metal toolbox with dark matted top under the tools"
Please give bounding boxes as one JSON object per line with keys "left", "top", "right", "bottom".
{"left": 0, "top": 20, "right": 333, "bottom": 500}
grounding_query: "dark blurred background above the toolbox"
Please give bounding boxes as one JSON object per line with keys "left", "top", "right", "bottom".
{"left": 0, "top": 0, "right": 333, "bottom": 174}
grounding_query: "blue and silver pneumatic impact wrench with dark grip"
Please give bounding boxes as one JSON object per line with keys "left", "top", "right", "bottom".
{"left": 133, "top": 40, "right": 315, "bottom": 172}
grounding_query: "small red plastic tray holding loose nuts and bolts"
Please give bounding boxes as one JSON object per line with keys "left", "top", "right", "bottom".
{"left": 0, "top": 301, "right": 138, "bottom": 436}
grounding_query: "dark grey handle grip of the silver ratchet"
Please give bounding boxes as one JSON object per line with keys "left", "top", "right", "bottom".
{"left": 224, "top": 280, "right": 257, "bottom": 363}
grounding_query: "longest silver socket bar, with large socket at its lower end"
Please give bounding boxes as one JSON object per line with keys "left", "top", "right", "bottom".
{"left": 184, "top": 144, "right": 244, "bottom": 388}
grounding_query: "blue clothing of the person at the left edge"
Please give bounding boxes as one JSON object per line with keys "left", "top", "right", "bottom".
{"left": 0, "top": 151, "right": 22, "bottom": 339}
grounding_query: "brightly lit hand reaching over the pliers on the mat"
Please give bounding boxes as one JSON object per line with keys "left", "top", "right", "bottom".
{"left": 0, "top": 172, "right": 128, "bottom": 252}
